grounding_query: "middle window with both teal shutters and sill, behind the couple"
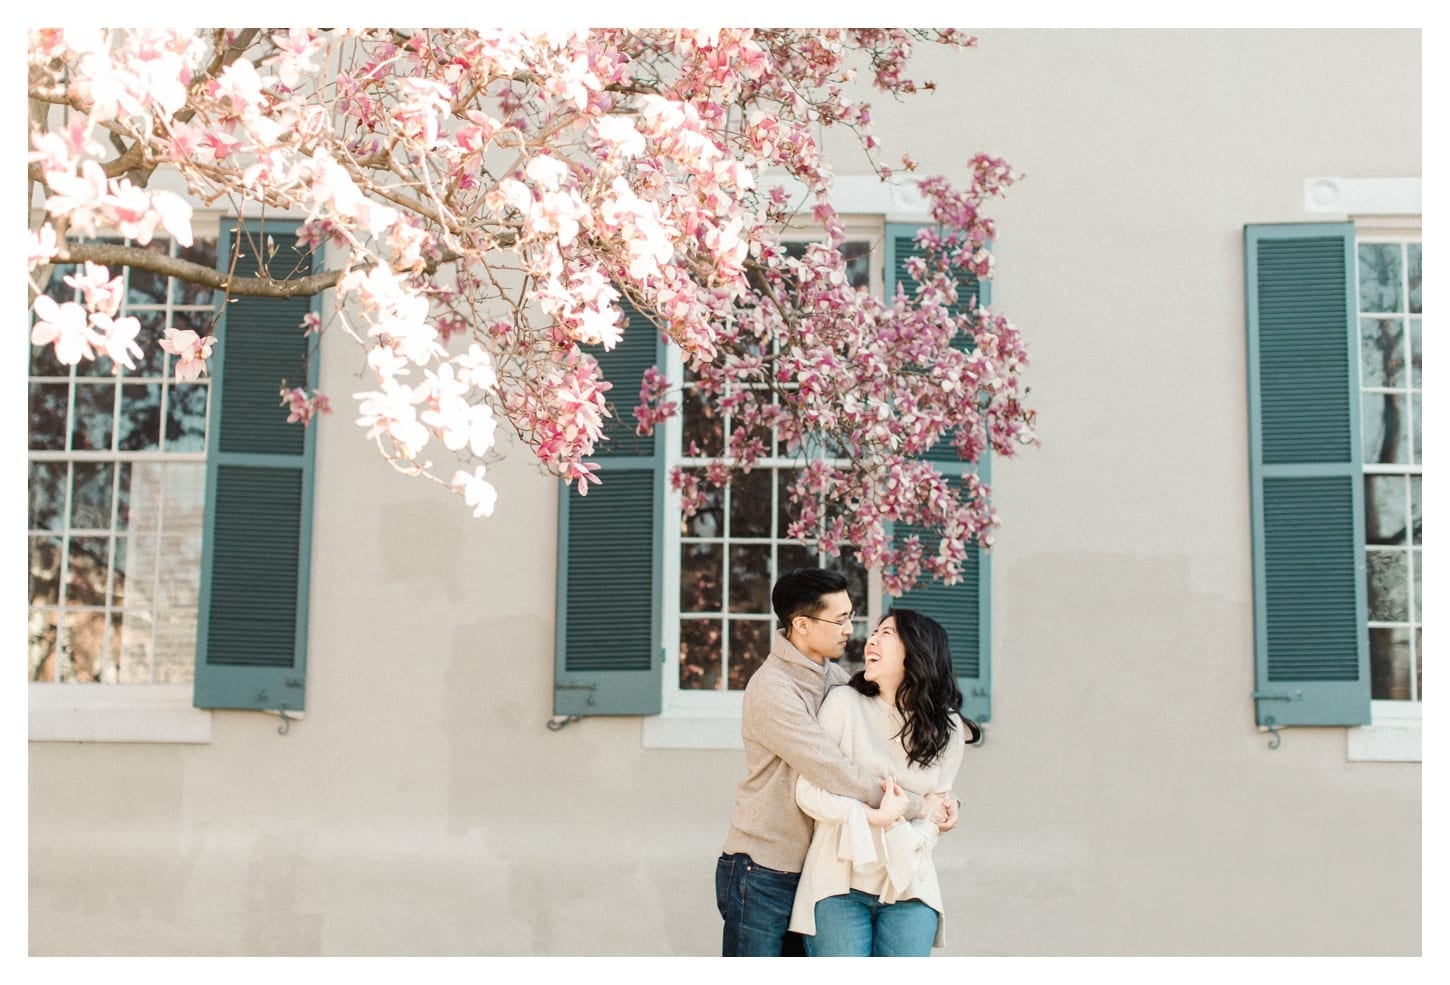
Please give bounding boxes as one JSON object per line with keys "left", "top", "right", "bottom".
{"left": 554, "top": 213, "right": 990, "bottom": 747}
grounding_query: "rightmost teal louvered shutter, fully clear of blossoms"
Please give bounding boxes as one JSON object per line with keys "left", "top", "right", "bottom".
{"left": 1244, "top": 223, "right": 1370, "bottom": 725}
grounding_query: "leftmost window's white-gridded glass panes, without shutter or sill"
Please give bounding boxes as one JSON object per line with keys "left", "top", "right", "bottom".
{"left": 26, "top": 236, "right": 218, "bottom": 683}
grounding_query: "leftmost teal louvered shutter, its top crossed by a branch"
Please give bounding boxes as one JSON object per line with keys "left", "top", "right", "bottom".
{"left": 193, "top": 222, "right": 316, "bottom": 711}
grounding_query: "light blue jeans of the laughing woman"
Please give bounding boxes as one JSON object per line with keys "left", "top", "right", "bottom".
{"left": 805, "top": 889, "right": 938, "bottom": 957}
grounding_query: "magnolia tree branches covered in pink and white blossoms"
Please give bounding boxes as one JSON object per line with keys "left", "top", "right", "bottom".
{"left": 29, "top": 29, "right": 1034, "bottom": 592}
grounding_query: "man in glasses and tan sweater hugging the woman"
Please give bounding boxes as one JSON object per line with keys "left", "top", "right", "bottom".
{"left": 715, "top": 567, "right": 957, "bottom": 957}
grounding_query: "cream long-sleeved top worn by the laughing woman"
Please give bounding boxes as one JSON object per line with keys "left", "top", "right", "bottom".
{"left": 790, "top": 686, "right": 964, "bottom": 947}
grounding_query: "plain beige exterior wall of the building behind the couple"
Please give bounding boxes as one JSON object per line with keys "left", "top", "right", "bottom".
{"left": 29, "top": 30, "right": 1421, "bottom": 955}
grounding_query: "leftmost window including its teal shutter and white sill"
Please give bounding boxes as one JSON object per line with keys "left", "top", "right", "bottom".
{"left": 26, "top": 223, "right": 316, "bottom": 741}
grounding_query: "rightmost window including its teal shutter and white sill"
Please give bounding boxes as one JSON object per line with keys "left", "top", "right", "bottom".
{"left": 1244, "top": 223, "right": 1422, "bottom": 760}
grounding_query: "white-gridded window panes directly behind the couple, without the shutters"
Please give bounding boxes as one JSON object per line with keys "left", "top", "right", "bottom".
{"left": 664, "top": 226, "right": 882, "bottom": 704}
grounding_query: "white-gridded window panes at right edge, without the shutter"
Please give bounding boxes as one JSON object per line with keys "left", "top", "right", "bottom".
{"left": 1357, "top": 236, "right": 1424, "bottom": 702}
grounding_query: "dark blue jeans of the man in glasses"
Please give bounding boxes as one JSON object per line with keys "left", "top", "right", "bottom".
{"left": 715, "top": 853, "right": 805, "bottom": 957}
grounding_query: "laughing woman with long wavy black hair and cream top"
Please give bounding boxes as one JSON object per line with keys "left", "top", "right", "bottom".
{"left": 790, "top": 609, "right": 980, "bottom": 957}
